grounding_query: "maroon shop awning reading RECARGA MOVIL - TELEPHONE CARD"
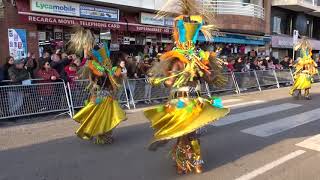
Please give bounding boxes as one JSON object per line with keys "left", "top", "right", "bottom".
{"left": 19, "top": 12, "right": 172, "bottom": 34}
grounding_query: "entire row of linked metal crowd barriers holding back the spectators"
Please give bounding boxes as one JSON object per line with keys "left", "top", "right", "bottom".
{"left": 0, "top": 69, "right": 306, "bottom": 119}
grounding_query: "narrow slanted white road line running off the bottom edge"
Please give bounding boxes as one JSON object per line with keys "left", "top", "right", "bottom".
{"left": 235, "top": 150, "right": 306, "bottom": 180}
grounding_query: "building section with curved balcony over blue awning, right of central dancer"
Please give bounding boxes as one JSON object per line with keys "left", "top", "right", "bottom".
{"left": 203, "top": 0, "right": 271, "bottom": 56}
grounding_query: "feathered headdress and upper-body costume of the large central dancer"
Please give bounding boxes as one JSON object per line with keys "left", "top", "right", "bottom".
{"left": 149, "top": 0, "right": 226, "bottom": 88}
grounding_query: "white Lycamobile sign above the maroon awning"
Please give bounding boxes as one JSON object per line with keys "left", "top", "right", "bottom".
{"left": 30, "top": 0, "right": 80, "bottom": 16}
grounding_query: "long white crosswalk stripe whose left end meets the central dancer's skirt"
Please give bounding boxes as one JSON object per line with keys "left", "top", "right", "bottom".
{"left": 212, "top": 103, "right": 301, "bottom": 126}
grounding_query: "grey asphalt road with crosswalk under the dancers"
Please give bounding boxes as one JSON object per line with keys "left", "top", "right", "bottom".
{"left": 0, "top": 84, "right": 320, "bottom": 180}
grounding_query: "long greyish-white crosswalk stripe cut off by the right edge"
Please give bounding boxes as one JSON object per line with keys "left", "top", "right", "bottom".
{"left": 241, "top": 108, "right": 320, "bottom": 137}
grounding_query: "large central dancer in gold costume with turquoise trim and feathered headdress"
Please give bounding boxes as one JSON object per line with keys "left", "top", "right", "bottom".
{"left": 144, "top": 0, "right": 229, "bottom": 174}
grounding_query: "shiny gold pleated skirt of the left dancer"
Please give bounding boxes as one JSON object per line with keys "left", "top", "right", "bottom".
{"left": 73, "top": 97, "right": 126, "bottom": 139}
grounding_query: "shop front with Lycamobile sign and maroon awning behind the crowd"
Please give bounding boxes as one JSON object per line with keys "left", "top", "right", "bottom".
{"left": 17, "top": 0, "right": 172, "bottom": 55}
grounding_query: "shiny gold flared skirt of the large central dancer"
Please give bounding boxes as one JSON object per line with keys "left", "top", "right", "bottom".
{"left": 144, "top": 98, "right": 230, "bottom": 144}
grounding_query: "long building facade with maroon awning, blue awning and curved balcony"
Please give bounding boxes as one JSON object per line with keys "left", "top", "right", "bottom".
{"left": 0, "top": 0, "right": 271, "bottom": 62}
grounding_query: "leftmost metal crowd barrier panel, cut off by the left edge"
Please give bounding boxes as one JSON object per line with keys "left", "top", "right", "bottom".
{"left": 0, "top": 82, "right": 71, "bottom": 119}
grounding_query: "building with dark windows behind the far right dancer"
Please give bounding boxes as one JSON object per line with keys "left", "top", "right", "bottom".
{"left": 271, "top": 0, "right": 320, "bottom": 59}
